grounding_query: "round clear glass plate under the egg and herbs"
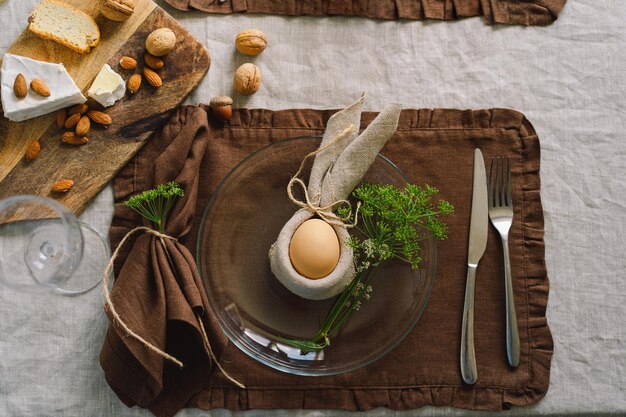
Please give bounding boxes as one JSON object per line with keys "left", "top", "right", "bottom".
{"left": 196, "top": 137, "right": 436, "bottom": 376}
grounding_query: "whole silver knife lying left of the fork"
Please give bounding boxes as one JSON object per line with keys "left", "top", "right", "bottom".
{"left": 461, "top": 149, "right": 489, "bottom": 384}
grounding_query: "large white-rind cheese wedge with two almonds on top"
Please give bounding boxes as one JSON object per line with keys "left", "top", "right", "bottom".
{"left": 0, "top": 54, "right": 87, "bottom": 122}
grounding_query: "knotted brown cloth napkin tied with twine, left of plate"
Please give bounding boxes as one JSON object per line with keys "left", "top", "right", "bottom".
{"left": 100, "top": 107, "right": 230, "bottom": 415}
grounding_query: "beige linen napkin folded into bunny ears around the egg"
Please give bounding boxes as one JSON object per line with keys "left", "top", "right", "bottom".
{"left": 269, "top": 95, "right": 401, "bottom": 300}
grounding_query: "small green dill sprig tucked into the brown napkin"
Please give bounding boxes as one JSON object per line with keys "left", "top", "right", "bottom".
{"left": 124, "top": 182, "right": 185, "bottom": 233}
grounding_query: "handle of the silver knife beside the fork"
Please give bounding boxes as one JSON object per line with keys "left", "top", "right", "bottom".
{"left": 461, "top": 265, "right": 478, "bottom": 384}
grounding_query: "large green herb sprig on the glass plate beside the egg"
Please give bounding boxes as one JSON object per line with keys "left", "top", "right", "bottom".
{"left": 281, "top": 183, "right": 454, "bottom": 354}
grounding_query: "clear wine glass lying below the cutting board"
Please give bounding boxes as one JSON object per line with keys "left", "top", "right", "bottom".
{"left": 0, "top": 195, "right": 109, "bottom": 295}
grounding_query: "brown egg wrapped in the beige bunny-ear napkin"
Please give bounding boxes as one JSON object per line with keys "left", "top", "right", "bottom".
{"left": 289, "top": 219, "right": 340, "bottom": 279}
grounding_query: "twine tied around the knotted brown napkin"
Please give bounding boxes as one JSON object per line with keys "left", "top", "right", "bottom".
{"left": 102, "top": 226, "right": 245, "bottom": 388}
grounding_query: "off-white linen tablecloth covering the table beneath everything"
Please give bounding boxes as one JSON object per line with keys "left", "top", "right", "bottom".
{"left": 0, "top": 0, "right": 626, "bottom": 417}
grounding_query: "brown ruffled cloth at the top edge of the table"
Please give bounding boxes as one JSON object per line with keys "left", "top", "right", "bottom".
{"left": 166, "top": 0, "right": 567, "bottom": 25}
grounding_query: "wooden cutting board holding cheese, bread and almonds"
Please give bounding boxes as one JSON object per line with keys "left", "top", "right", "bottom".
{"left": 0, "top": 0, "right": 210, "bottom": 214}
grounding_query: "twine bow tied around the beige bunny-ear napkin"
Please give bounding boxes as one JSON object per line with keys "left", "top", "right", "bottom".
{"left": 287, "top": 124, "right": 361, "bottom": 228}
